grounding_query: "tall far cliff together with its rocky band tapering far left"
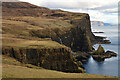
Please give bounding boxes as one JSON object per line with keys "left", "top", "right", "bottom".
{"left": 30, "top": 14, "right": 95, "bottom": 52}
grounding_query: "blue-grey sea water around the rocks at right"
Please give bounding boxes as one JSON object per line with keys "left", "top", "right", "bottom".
{"left": 84, "top": 26, "right": 120, "bottom": 77}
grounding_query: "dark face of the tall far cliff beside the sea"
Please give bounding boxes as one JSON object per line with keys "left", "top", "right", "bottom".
{"left": 53, "top": 15, "right": 95, "bottom": 52}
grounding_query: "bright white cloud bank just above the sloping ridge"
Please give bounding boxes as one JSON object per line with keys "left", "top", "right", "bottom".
{"left": 40, "top": 1, "right": 91, "bottom": 9}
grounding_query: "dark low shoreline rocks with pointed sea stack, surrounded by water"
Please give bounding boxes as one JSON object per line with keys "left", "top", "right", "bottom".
{"left": 72, "top": 44, "right": 117, "bottom": 64}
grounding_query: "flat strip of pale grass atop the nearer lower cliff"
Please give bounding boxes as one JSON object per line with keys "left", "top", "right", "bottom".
{"left": 3, "top": 38, "right": 65, "bottom": 48}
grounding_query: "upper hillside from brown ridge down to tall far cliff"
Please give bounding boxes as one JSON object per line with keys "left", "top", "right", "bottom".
{"left": 3, "top": 2, "right": 95, "bottom": 51}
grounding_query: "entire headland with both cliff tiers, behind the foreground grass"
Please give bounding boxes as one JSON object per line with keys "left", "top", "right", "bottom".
{"left": 1, "top": 2, "right": 113, "bottom": 77}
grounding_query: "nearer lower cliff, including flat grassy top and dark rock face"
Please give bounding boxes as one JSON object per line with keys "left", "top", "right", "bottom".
{"left": 2, "top": 34, "right": 84, "bottom": 72}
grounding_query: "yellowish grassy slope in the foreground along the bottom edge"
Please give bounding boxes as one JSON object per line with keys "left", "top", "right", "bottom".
{"left": 2, "top": 56, "right": 117, "bottom": 80}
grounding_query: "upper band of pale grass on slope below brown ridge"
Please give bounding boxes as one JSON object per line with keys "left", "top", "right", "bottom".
{"left": 4, "top": 16, "right": 72, "bottom": 29}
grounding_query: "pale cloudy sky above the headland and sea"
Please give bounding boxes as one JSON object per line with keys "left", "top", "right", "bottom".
{"left": 1, "top": 0, "right": 119, "bottom": 24}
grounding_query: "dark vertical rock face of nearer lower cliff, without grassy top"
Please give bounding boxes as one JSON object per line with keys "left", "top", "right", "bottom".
{"left": 2, "top": 47, "right": 85, "bottom": 73}
